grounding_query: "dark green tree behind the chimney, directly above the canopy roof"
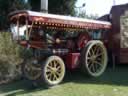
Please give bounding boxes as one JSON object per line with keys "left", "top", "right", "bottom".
{"left": 29, "top": 0, "right": 77, "bottom": 16}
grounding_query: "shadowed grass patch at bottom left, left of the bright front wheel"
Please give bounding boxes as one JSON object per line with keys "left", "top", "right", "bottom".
{"left": 0, "top": 80, "right": 48, "bottom": 96}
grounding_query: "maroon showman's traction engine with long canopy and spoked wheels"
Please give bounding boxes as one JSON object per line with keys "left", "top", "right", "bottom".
{"left": 9, "top": 11, "right": 111, "bottom": 86}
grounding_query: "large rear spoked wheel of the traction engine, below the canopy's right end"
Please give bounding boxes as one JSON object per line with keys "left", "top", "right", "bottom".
{"left": 81, "top": 41, "right": 108, "bottom": 77}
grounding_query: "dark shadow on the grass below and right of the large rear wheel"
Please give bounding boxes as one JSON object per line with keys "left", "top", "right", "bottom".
{"left": 66, "top": 65, "right": 128, "bottom": 86}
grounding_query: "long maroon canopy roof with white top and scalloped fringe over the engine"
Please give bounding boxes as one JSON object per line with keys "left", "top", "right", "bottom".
{"left": 9, "top": 10, "right": 111, "bottom": 29}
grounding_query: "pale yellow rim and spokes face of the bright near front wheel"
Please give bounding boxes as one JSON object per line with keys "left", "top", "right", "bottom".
{"left": 45, "top": 56, "right": 65, "bottom": 84}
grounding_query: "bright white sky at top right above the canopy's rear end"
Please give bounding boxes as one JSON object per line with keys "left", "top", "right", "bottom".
{"left": 76, "top": 0, "right": 128, "bottom": 16}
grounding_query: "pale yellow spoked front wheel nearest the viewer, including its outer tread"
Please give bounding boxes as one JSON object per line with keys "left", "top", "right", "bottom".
{"left": 42, "top": 56, "right": 65, "bottom": 86}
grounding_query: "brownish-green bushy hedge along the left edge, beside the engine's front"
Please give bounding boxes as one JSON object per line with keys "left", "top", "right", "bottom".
{"left": 0, "top": 32, "right": 23, "bottom": 84}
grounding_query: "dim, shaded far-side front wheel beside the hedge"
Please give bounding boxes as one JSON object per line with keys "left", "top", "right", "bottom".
{"left": 23, "top": 60, "right": 42, "bottom": 81}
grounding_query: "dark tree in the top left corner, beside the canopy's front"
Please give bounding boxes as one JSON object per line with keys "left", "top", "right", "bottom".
{"left": 0, "top": 0, "right": 30, "bottom": 30}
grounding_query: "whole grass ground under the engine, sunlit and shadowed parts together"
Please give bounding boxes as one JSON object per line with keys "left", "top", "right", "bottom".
{"left": 0, "top": 65, "right": 128, "bottom": 96}
